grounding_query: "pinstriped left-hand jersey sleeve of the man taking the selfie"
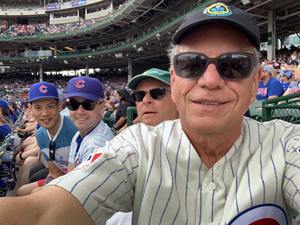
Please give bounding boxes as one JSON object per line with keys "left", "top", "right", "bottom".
{"left": 49, "top": 127, "right": 139, "bottom": 225}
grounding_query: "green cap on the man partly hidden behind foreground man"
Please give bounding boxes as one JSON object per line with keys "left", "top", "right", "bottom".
{"left": 128, "top": 68, "right": 171, "bottom": 89}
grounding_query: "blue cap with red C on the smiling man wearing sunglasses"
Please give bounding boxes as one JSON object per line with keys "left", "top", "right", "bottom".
{"left": 66, "top": 77, "right": 104, "bottom": 101}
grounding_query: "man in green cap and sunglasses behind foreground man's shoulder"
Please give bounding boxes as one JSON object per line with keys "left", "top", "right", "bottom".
{"left": 128, "top": 68, "right": 178, "bottom": 126}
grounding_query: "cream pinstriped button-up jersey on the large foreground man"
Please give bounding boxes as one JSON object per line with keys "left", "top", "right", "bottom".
{"left": 51, "top": 118, "right": 300, "bottom": 225}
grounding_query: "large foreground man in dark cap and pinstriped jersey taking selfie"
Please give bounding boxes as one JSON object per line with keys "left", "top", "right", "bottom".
{"left": 0, "top": 3, "right": 300, "bottom": 225}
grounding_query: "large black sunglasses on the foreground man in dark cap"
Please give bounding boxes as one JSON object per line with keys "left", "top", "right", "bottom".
{"left": 173, "top": 52, "right": 254, "bottom": 80}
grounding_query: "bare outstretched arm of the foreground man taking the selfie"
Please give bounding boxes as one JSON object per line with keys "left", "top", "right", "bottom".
{"left": 0, "top": 186, "right": 94, "bottom": 225}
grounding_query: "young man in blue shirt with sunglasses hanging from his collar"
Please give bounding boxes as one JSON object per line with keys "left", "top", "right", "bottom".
{"left": 16, "top": 82, "right": 77, "bottom": 196}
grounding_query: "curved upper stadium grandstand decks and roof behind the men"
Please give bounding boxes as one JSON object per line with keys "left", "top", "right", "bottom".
{"left": 0, "top": 0, "right": 300, "bottom": 84}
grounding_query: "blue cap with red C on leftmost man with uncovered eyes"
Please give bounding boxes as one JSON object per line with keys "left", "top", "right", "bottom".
{"left": 28, "top": 81, "right": 59, "bottom": 102}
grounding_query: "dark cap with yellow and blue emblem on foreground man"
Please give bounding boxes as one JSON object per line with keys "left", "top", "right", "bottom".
{"left": 172, "top": 2, "right": 260, "bottom": 50}
